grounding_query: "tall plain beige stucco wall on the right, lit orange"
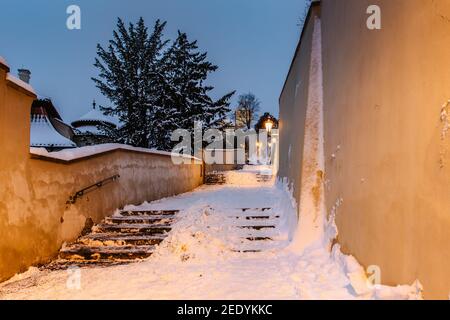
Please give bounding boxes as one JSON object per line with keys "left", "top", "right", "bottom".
{"left": 280, "top": 0, "right": 450, "bottom": 299}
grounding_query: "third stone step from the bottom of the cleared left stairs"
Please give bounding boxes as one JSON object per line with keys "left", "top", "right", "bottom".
{"left": 77, "top": 233, "right": 167, "bottom": 246}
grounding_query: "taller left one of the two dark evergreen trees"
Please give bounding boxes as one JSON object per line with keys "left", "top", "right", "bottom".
{"left": 93, "top": 18, "right": 167, "bottom": 148}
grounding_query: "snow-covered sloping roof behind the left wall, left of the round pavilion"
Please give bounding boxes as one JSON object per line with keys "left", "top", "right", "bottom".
{"left": 30, "top": 115, "right": 76, "bottom": 148}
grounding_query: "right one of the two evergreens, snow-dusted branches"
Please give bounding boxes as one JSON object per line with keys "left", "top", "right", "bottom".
{"left": 154, "top": 31, "right": 234, "bottom": 149}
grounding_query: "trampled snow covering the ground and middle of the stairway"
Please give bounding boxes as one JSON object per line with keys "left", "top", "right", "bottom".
{"left": 0, "top": 172, "right": 418, "bottom": 300}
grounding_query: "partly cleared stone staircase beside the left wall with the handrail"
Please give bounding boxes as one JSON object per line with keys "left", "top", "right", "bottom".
{"left": 48, "top": 210, "right": 179, "bottom": 269}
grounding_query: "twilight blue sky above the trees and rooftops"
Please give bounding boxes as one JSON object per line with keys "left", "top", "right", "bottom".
{"left": 0, "top": 0, "right": 304, "bottom": 122}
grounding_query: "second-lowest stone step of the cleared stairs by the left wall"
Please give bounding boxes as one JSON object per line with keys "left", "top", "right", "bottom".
{"left": 59, "top": 245, "right": 154, "bottom": 260}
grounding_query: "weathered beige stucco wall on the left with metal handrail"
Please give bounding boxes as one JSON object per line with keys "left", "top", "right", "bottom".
{"left": 0, "top": 59, "right": 203, "bottom": 281}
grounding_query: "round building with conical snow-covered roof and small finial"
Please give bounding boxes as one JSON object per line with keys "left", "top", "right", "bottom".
{"left": 72, "top": 101, "right": 119, "bottom": 147}
